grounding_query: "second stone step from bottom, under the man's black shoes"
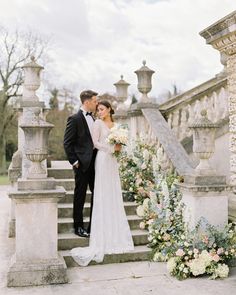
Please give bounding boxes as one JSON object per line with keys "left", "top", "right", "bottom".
{"left": 58, "top": 229, "right": 148, "bottom": 250}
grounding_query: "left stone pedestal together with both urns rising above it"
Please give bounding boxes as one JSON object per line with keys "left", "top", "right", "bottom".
{"left": 7, "top": 58, "right": 68, "bottom": 287}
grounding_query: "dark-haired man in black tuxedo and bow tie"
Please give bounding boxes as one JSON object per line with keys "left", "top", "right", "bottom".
{"left": 64, "top": 90, "right": 97, "bottom": 237}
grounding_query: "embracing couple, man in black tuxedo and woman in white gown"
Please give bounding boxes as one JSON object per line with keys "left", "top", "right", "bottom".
{"left": 64, "top": 90, "right": 134, "bottom": 266}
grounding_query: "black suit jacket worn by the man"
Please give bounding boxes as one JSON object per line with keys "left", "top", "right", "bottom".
{"left": 64, "top": 110, "right": 94, "bottom": 171}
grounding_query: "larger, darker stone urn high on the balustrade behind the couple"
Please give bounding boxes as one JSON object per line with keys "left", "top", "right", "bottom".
{"left": 135, "top": 60, "right": 155, "bottom": 103}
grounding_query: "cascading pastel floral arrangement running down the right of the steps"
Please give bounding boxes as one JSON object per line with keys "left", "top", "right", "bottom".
{"left": 120, "top": 140, "right": 236, "bottom": 279}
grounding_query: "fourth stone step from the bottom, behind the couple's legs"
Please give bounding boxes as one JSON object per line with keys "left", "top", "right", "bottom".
{"left": 58, "top": 202, "right": 137, "bottom": 217}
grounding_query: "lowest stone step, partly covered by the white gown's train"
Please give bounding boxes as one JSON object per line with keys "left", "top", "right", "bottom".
{"left": 60, "top": 246, "right": 151, "bottom": 267}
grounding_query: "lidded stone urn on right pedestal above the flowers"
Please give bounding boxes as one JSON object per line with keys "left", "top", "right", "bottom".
{"left": 189, "top": 110, "right": 218, "bottom": 175}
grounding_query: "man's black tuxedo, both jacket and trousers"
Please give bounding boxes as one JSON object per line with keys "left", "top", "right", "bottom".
{"left": 64, "top": 110, "right": 96, "bottom": 231}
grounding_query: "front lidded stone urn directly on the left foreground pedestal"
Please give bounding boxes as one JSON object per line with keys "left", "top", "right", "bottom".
{"left": 20, "top": 108, "right": 53, "bottom": 179}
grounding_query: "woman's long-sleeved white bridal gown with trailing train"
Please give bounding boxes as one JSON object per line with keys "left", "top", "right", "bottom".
{"left": 71, "top": 120, "right": 134, "bottom": 266}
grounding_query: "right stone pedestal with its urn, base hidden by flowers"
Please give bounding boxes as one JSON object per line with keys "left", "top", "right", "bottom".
{"left": 179, "top": 110, "right": 229, "bottom": 229}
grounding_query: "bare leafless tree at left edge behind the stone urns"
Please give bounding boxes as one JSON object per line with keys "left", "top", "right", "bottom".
{"left": 0, "top": 27, "right": 49, "bottom": 171}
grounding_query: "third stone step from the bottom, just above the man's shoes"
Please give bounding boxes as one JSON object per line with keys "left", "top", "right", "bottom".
{"left": 58, "top": 215, "right": 142, "bottom": 233}
